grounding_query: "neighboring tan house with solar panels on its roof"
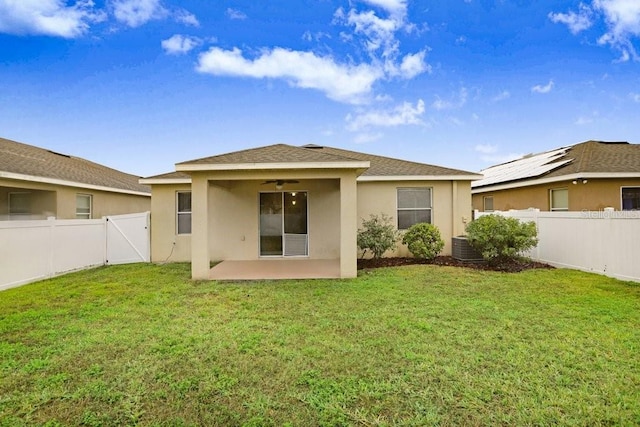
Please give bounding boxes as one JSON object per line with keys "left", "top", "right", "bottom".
{"left": 471, "top": 141, "right": 640, "bottom": 212}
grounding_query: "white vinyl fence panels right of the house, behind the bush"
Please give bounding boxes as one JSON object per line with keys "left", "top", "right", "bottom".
{"left": 476, "top": 208, "right": 640, "bottom": 282}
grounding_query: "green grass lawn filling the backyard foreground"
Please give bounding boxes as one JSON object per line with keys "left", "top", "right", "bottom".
{"left": 0, "top": 264, "right": 640, "bottom": 426}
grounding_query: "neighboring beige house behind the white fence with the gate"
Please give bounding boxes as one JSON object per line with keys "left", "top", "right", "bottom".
{"left": 0, "top": 138, "right": 151, "bottom": 220}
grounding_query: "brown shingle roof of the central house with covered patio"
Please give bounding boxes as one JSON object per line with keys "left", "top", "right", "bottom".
{"left": 171, "top": 144, "right": 479, "bottom": 178}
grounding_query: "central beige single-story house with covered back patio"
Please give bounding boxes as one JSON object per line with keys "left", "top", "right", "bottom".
{"left": 140, "top": 144, "right": 481, "bottom": 279}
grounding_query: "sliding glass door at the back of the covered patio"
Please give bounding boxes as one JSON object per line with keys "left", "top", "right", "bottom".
{"left": 260, "top": 191, "right": 309, "bottom": 256}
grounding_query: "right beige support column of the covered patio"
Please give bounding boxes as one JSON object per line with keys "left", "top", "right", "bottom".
{"left": 340, "top": 174, "right": 358, "bottom": 278}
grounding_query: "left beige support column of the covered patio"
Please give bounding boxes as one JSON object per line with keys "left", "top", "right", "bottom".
{"left": 191, "top": 173, "right": 210, "bottom": 280}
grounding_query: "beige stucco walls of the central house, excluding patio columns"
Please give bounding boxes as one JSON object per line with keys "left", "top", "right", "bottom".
{"left": 151, "top": 171, "right": 471, "bottom": 262}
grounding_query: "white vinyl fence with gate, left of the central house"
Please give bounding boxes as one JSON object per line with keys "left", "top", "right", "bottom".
{"left": 0, "top": 212, "right": 150, "bottom": 290}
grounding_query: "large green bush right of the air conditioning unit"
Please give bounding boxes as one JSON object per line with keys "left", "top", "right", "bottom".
{"left": 467, "top": 214, "right": 538, "bottom": 264}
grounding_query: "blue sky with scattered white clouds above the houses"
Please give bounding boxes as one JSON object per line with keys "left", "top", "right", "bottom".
{"left": 0, "top": 0, "right": 640, "bottom": 176}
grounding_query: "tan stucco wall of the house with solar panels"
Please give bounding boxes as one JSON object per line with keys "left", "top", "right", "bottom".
{"left": 473, "top": 179, "right": 640, "bottom": 211}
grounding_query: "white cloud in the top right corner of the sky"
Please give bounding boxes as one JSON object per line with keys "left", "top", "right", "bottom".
{"left": 548, "top": 0, "right": 640, "bottom": 62}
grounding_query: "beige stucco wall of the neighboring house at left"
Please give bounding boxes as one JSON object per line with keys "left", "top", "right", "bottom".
{"left": 0, "top": 179, "right": 151, "bottom": 219}
